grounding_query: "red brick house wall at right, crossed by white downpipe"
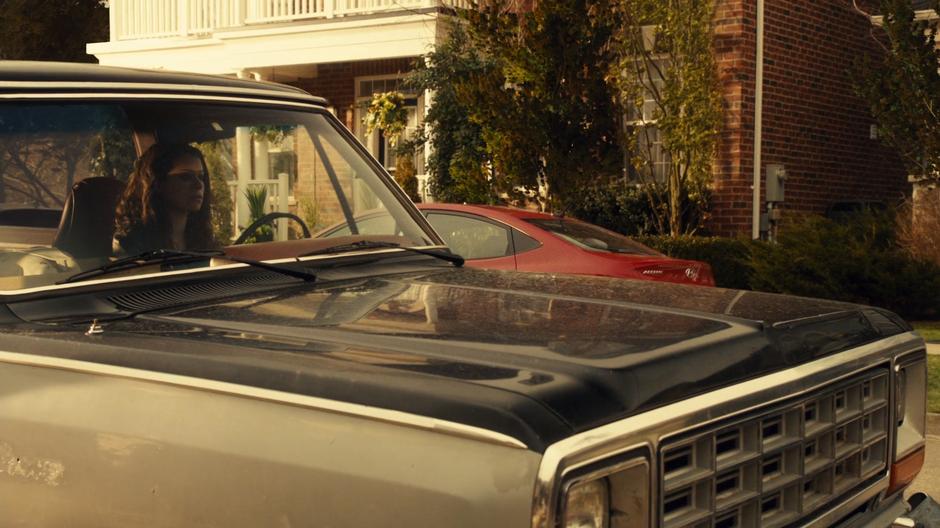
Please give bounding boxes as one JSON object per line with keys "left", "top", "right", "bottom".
{"left": 710, "top": 0, "right": 910, "bottom": 235}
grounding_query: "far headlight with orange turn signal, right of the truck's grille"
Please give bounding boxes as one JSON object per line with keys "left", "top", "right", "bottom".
{"left": 888, "top": 351, "right": 927, "bottom": 494}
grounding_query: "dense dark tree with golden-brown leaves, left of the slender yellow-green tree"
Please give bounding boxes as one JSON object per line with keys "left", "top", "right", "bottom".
{"left": 458, "top": 0, "right": 622, "bottom": 211}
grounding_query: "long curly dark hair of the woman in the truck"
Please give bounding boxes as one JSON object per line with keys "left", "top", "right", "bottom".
{"left": 114, "top": 143, "right": 218, "bottom": 253}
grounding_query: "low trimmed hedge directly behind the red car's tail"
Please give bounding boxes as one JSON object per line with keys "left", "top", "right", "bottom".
{"left": 637, "top": 235, "right": 752, "bottom": 289}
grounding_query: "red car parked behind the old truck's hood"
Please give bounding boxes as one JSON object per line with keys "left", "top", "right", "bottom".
{"left": 418, "top": 203, "right": 715, "bottom": 286}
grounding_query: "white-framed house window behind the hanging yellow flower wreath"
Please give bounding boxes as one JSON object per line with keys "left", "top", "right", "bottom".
{"left": 355, "top": 76, "right": 424, "bottom": 174}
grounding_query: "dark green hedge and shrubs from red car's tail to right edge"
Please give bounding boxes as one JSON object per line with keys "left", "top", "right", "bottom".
{"left": 637, "top": 213, "right": 940, "bottom": 320}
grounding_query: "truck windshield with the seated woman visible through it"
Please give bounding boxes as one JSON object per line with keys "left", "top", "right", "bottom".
{"left": 0, "top": 100, "right": 435, "bottom": 291}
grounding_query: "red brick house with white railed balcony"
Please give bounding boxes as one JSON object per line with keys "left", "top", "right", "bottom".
{"left": 88, "top": 0, "right": 910, "bottom": 235}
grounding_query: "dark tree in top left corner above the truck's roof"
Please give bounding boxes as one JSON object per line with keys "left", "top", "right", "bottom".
{"left": 0, "top": 0, "right": 108, "bottom": 62}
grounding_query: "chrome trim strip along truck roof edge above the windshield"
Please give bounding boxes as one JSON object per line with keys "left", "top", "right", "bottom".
{"left": 0, "top": 81, "right": 327, "bottom": 106}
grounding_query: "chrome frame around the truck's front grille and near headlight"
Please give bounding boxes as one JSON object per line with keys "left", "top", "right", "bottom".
{"left": 532, "top": 332, "right": 924, "bottom": 528}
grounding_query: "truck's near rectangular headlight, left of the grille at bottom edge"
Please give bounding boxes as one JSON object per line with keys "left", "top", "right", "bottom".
{"left": 561, "top": 457, "right": 650, "bottom": 528}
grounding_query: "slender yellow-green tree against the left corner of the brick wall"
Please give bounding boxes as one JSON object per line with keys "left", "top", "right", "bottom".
{"left": 614, "top": 0, "right": 722, "bottom": 236}
